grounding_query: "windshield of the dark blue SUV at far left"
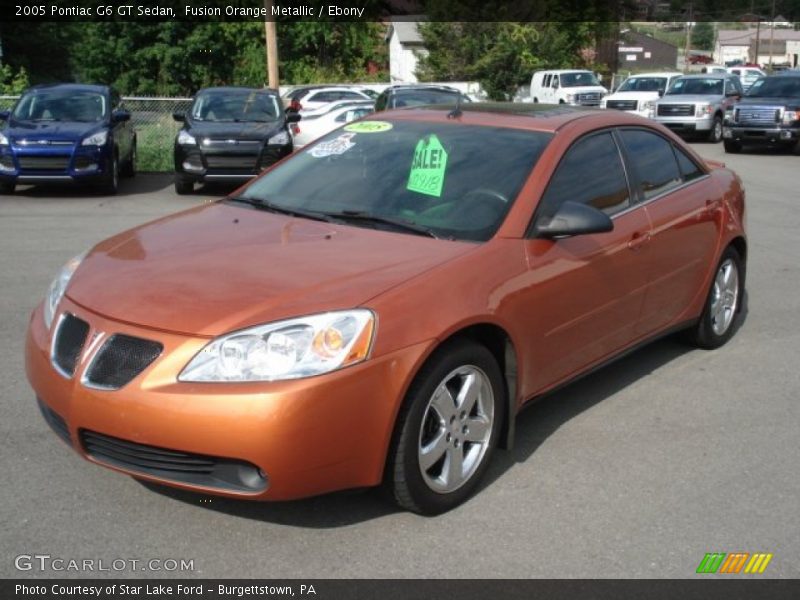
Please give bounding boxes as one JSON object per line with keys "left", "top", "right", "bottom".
{"left": 14, "top": 90, "right": 108, "bottom": 123}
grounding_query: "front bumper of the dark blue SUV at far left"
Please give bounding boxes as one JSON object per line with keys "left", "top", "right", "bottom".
{"left": 0, "top": 145, "right": 111, "bottom": 184}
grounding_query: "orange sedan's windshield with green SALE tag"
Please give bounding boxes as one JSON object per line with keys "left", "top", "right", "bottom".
{"left": 236, "top": 120, "right": 552, "bottom": 241}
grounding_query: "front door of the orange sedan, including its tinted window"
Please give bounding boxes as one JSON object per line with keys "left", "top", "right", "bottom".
{"left": 521, "top": 130, "right": 650, "bottom": 395}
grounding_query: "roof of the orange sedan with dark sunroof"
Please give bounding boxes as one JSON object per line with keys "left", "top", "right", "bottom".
{"left": 380, "top": 102, "right": 664, "bottom": 133}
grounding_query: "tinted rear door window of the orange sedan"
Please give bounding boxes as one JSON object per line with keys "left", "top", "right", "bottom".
{"left": 620, "top": 129, "right": 683, "bottom": 200}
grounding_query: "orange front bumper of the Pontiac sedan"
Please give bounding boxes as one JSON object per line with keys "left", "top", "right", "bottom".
{"left": 26, "top": 298, "right": 427, "bottom": 500}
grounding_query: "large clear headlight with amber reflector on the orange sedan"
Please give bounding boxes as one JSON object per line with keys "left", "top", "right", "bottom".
{"left": 178, "top": 309, "right": 375, "bottom": 382}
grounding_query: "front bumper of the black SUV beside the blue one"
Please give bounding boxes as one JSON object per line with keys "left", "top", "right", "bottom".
{"left": 175, "top": 142, "right": 292, "bottom": 183}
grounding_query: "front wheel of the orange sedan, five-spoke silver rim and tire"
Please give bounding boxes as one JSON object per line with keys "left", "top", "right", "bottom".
{"left": 386, "top": 340, "right": 505, "bottom": 515}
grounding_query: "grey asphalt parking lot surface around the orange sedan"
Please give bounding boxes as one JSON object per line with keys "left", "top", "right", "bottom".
{"left": 0, "top": 144, "right": 800, "bottom": 578}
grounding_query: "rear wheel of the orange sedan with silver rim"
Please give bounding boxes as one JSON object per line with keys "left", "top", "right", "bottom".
{"left": 688, "top": 246, "right": 745, "bottom": 350}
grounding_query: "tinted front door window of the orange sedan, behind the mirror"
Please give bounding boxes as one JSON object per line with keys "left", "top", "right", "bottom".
{"left": 538, "top": 132, "right": 632, "bottom": 217}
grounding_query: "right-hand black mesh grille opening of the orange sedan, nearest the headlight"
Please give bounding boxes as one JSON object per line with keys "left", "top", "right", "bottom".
{"left": 86, "top": 334, "right": 164, "bottom": 390}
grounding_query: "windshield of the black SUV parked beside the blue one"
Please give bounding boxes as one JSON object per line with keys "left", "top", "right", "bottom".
{"left": 191, "top": 90, "right": 281, "bottom": 123}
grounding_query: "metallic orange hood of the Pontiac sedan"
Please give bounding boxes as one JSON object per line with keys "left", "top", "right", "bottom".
{"left": 67, "top": 203, "right": 476, "bottom": 336}
